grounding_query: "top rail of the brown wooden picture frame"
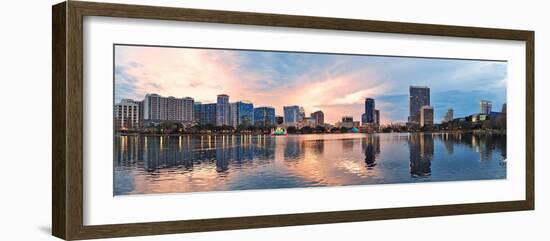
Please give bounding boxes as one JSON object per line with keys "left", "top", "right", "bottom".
{"left": 68, "top": 0, "right": 532, "bottom": 40}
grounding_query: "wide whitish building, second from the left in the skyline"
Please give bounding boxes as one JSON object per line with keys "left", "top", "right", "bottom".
{"left": 143, "top": 94, "right": 195, "bottom": 122}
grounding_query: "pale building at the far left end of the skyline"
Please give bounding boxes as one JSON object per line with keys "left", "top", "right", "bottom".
{"left": 114, "top": 99, "right": 139, "bottom": 130}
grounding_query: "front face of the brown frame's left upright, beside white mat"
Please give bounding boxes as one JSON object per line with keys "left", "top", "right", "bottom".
{"left": 65, "top": 1, "right": 84, "bottom": 240}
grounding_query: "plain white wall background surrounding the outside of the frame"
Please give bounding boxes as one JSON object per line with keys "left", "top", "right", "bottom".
{"left": 0, "top": 0, "right": 550, "bottom": 241}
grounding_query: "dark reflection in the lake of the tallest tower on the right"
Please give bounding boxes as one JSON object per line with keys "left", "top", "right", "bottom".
{"left": 409, "top": 133, "right": 434, "bottom": 177}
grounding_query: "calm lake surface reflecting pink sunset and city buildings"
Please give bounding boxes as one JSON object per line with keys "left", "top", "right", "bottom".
{"left": 114, "top": 133, "right": 506, "bottom": 195}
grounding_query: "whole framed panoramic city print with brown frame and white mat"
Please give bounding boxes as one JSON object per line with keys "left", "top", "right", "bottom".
{"left": 52, "top": 1, "right": 534, "bottom": 240}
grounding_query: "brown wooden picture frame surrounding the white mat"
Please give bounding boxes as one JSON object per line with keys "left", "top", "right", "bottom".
{"left": 52, "top": 1, "right": 535, "bottom": 240}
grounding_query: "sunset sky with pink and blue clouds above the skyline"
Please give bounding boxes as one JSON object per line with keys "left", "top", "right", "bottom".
{"left": 114, "top": 45, "right": 507, "bottom": 124}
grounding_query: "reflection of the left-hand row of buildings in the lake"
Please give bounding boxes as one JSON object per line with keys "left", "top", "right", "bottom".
{"left": 114, "top": 135, "right": 275, "bottom": 173}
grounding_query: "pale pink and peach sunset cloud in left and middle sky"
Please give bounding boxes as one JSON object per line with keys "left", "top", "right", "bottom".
{"left": 116, "top": 46, "right": 389, "bottom": 123}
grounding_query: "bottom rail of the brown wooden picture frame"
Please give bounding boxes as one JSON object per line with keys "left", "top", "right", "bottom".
{"left": 71, "top": 200, "right": 531, "bottom": 239}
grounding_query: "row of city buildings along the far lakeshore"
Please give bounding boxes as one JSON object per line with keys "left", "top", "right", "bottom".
{"left": 115, "top": 89, "right": 506, "bottom": 128}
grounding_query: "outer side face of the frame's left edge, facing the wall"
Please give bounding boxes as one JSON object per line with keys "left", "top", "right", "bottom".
{"left": 51, "top": 2, "right": 67, "bottom": 239}
